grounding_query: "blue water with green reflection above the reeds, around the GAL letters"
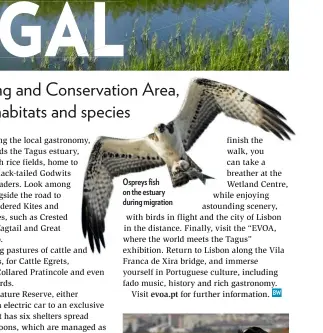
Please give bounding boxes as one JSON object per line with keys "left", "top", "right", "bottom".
{"left": 0, "top": 0, "right": 289, "bottom": 69}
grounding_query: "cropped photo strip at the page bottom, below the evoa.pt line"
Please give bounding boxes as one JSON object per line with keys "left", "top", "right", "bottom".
{"left": 123, "top": 313, "right": 289, "bottom": 333}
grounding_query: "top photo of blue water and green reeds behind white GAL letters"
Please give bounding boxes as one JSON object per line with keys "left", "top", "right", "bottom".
{"left": 0, "top": 0, "right": 289, "bottom": 70}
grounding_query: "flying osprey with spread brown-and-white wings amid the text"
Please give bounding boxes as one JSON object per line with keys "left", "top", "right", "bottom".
{"left": 82, "top": 79, "right": 294, "bottom": 252}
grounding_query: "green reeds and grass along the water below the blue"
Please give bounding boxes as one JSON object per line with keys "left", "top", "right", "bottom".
{"left": 25, "top": 19, "right": 289, "bottom": 70}
